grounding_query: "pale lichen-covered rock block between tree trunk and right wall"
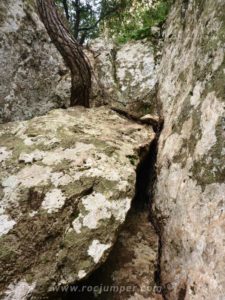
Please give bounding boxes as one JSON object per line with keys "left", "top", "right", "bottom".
{"left": 89, "top": 39, "right": 157, "bottom": 116}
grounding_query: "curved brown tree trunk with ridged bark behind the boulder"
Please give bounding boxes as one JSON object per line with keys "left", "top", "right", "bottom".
{"left": 37, "top": 0, "right": 91, "bottom": 107}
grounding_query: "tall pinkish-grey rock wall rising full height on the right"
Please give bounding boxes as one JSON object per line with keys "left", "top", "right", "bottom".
{"left": 155, "top": 0, "right": 225, "bottom": 300}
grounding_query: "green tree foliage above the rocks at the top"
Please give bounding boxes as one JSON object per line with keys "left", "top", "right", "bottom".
{"left": 55, "top": 0, "right": 172, "bottom": 44}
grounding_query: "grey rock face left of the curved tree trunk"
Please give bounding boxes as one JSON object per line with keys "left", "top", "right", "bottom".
{"left": 0, "top": 0, "right": 70, "bottom": 123}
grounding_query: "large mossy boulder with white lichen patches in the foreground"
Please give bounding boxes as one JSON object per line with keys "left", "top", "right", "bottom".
{"left": 0, "top": 107, "right": 154, "bottom": 299}
